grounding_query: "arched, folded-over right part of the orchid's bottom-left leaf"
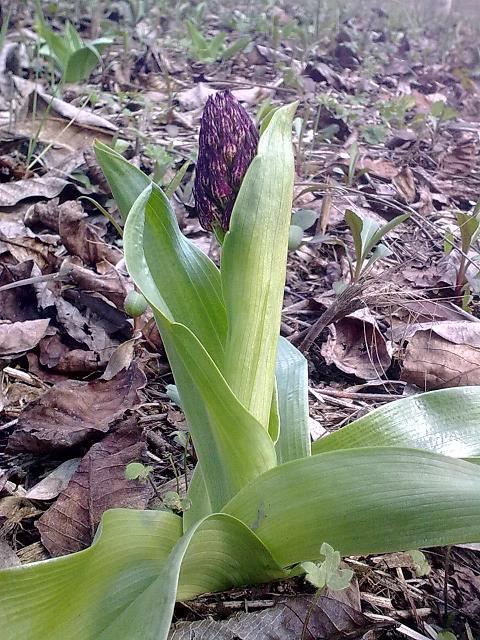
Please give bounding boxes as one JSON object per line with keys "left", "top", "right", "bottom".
{"left": 95, "top": 514, "right": 288, "bottom": 640}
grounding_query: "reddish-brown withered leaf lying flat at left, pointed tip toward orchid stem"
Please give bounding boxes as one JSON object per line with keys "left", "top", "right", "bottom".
{"left": 8, "top": 363, "right": 146, "bottom": 453}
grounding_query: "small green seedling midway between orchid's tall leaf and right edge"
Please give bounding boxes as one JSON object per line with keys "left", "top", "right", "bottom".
{"left": 345, "top": 209, "right": 410, "bottom": 282}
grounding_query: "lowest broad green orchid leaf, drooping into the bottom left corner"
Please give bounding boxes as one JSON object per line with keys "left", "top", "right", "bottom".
{"left": 0, "top": 509, "right": 288, "bottom": 640}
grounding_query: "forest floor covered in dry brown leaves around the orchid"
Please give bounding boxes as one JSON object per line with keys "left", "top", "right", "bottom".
{"left": 0, "top": 1, "right": 480, "bottom": 640}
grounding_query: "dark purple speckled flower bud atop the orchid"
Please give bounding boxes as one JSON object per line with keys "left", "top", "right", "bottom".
{"left": 194, "top": 91, "right": 258, "bottom": 231}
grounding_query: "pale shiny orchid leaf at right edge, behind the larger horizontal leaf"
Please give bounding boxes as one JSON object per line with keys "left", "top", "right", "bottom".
{"left": 312, "top": 387, "right": 480, "bottom": 458}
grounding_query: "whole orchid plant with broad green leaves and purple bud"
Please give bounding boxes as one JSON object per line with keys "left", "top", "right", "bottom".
{"left": 0, "top": 92, "right": 480, "bottom": 640}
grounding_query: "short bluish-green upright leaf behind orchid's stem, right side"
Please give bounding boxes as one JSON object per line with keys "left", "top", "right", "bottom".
{"left": 275, "top": 338, "right": 310, "bottom": 463}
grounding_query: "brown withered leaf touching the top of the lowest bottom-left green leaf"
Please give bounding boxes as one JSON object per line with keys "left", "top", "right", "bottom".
{"left": 36, "top": 422, "right": 152, "bottom": 556}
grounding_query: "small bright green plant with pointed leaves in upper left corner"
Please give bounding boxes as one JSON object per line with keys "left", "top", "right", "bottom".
{"left": 37, "top": 2, "right": 113, "bottom": 84}
